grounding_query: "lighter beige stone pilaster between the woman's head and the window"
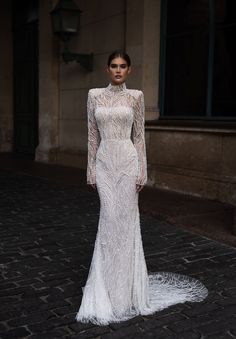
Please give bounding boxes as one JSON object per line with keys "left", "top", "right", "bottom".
{"left": 126, "top": 0, "right": 161, "bottom": 120}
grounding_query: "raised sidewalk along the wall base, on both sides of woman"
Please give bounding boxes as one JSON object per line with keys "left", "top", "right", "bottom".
{"left": 0, "top": 153, "right": 236, "bottom": 247}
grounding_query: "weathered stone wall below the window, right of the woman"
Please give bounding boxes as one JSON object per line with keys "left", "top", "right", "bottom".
{"left": 146, "top": 127, "right": 236, "bottom": 205}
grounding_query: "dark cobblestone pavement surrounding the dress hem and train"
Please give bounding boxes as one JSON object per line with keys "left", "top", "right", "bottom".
{"left": 0, "top": 170, "right": 236, "bottom": 339}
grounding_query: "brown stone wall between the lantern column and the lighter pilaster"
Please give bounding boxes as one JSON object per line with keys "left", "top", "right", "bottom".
{"left": 57, "top": 0, "right": 126, "bottom": 167}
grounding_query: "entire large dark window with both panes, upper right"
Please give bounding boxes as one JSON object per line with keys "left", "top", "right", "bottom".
{"left": 160, "top": 0, "right": 236, "bottom": 120}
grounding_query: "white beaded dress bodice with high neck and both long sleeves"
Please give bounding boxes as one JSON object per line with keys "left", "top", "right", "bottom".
{"left": 87, "top": 83, "right": 147, "bottom": 184}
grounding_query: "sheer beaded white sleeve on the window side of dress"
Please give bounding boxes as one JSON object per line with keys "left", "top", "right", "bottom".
{"left": 133, "top": 92, "right": 147, "bottom": 185}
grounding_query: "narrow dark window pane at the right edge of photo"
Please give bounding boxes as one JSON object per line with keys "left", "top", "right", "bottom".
{"left": 212, "top": 0, "right": 236, "bottom": 117}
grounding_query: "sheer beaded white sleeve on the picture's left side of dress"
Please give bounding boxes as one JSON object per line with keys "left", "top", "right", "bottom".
{"left": 87, "top": 91, "right": 100, "bottom": 184}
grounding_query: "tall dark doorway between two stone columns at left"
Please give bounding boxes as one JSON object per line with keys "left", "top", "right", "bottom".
{"left": 12, "top": 0, "right": 39, "bottom": 157}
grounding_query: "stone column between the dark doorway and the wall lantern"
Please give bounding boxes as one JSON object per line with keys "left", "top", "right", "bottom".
{"left": 35, "top": 0, "right": 60, "bottom": 162}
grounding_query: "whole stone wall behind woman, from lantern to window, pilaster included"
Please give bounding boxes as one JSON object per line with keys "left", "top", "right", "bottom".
{"left": 57, "top": 0, "right": 160, "bottom": 167}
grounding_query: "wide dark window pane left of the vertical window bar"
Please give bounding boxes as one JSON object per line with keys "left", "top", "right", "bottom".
{"left": 163, "top": 0, "right": 209, "bottom": 116}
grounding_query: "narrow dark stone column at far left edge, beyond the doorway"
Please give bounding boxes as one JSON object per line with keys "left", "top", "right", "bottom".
{"left": 0, "top": 0, "right": 13, "bottom": 152}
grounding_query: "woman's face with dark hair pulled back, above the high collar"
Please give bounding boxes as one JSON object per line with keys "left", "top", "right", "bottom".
{"left": 107, "top": 57, "right": 131, "bottom": 85}
